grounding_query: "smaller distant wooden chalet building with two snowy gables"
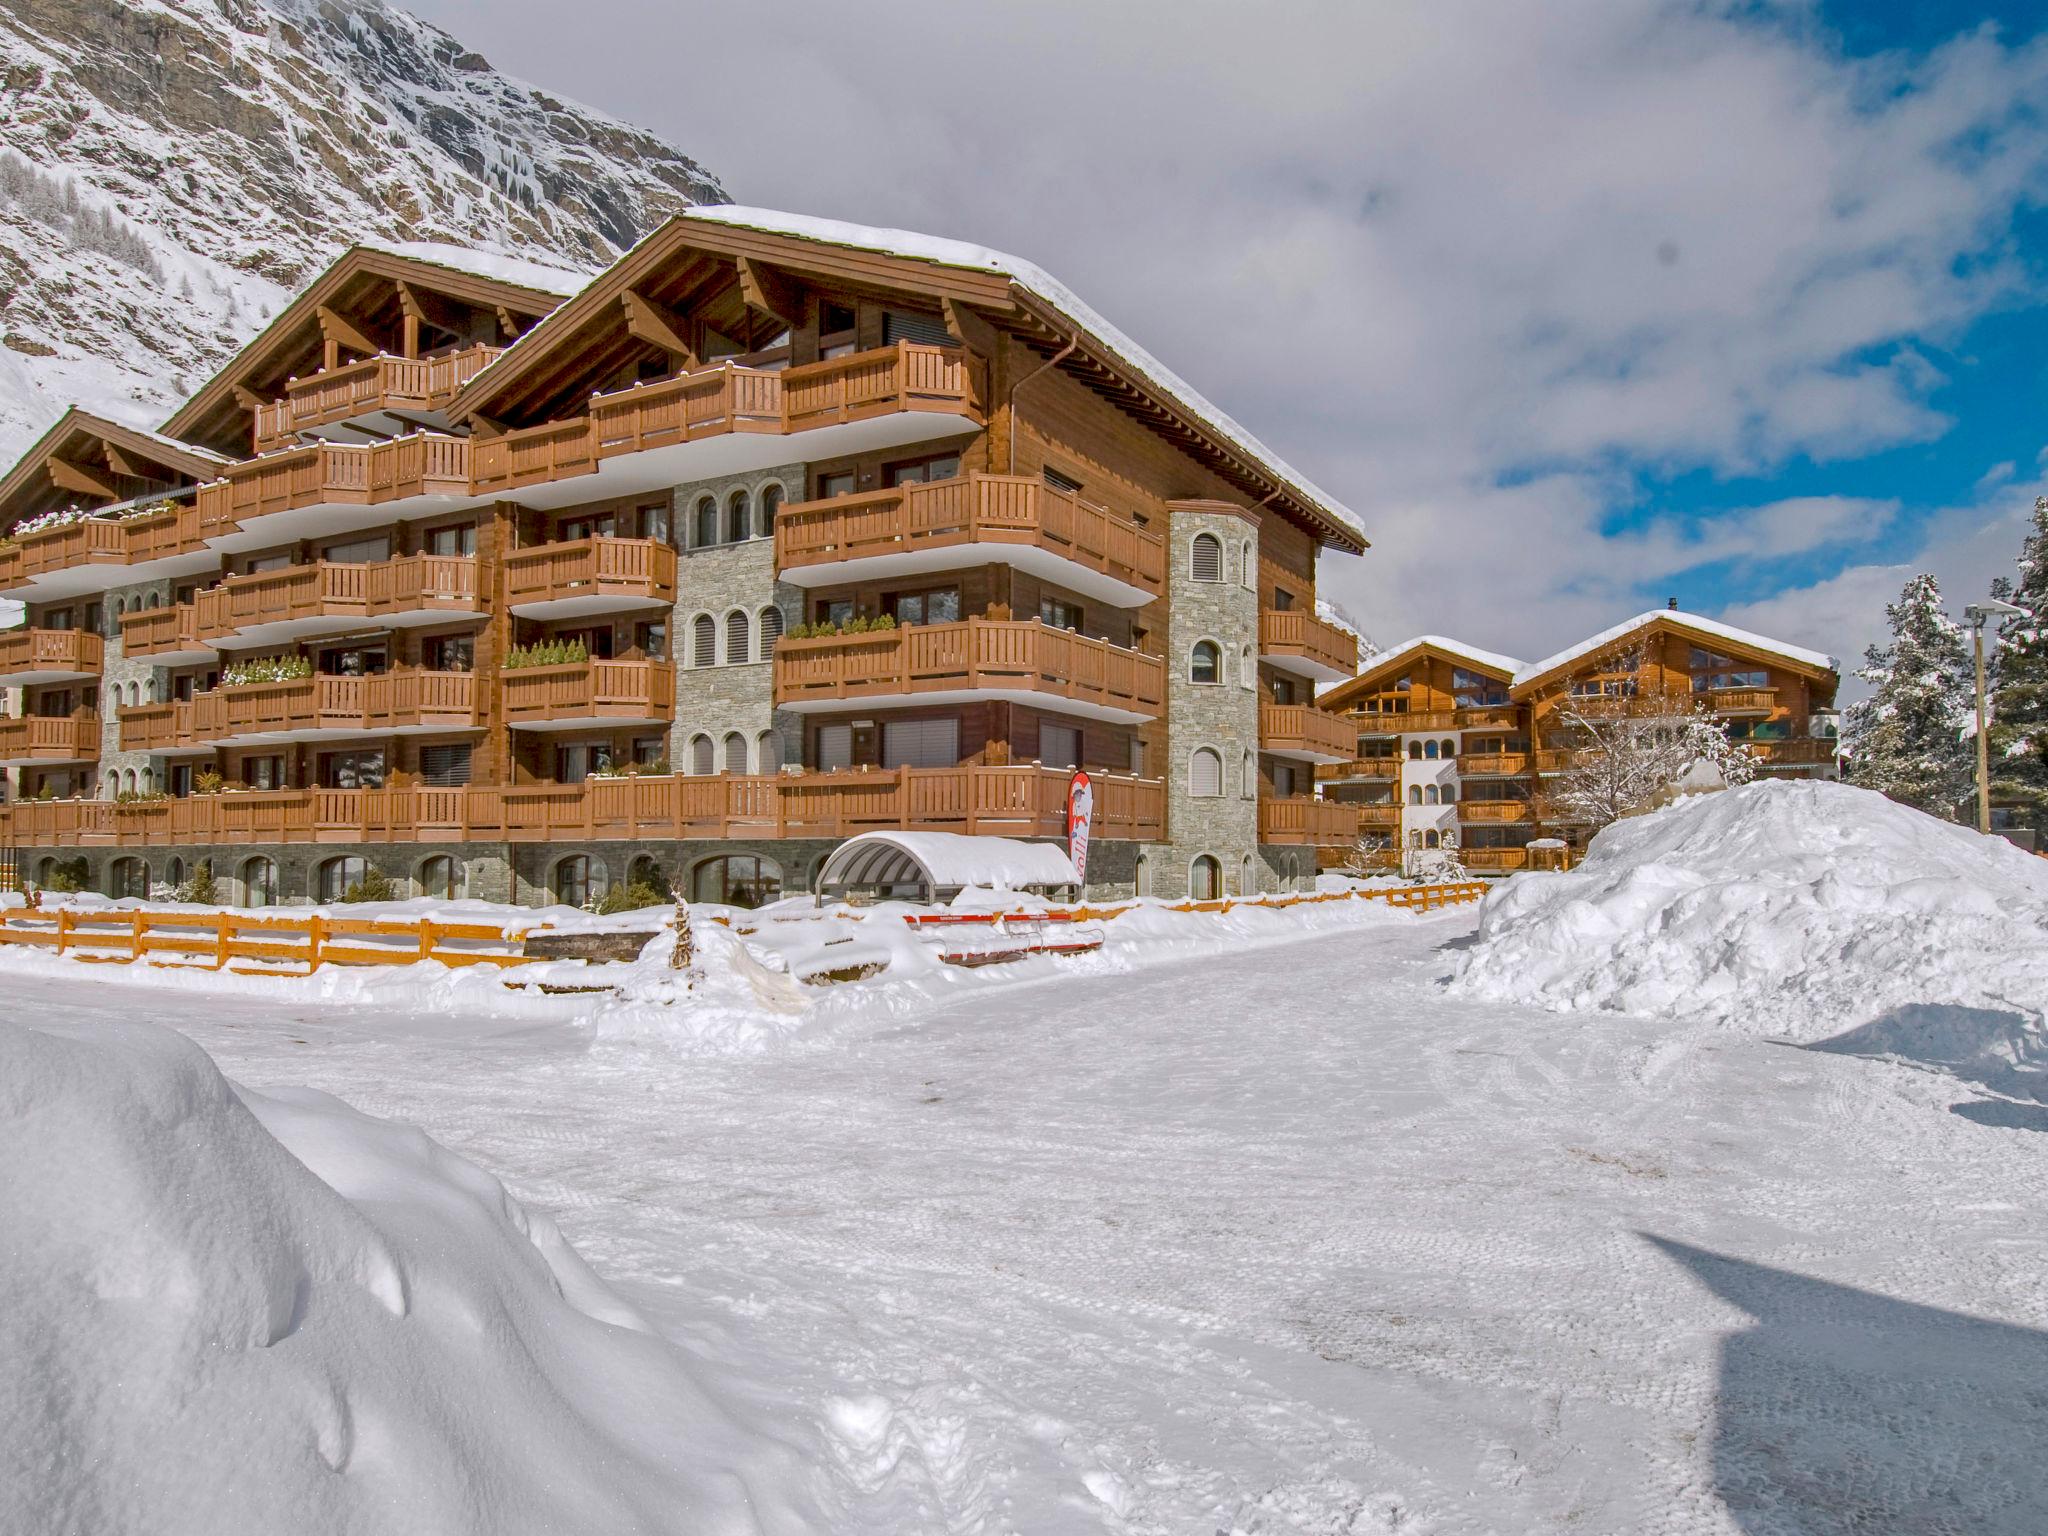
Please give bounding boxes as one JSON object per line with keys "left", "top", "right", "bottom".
{"left": 1317, "top": 608, "right": 1839, "bottom": 874}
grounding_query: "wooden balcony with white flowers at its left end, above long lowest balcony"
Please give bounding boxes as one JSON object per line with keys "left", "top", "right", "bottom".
{"left": 190, "top": 668, "right": 479, "bottom": 745}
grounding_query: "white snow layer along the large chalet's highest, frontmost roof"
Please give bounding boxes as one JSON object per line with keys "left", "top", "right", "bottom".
{"left": 682, "top": 203, "right": 1366, "bottom": 543}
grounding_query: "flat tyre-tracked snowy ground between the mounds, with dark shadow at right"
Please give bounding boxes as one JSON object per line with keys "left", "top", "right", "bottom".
{"left": 0, "top": 872, "right": 2048, "bottom": 1536}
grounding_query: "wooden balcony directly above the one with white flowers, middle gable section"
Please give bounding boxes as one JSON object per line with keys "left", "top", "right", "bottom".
{"left": 193, "top": 555, "right": 483, "bottom": 645}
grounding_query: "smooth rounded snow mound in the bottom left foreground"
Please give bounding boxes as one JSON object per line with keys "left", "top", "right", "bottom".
{"left": 0, "top": 1022, "right": 823, "bottom": 1534}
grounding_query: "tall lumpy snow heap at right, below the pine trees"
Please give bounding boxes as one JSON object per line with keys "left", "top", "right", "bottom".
{"left": 1452, "top": 780, "right": 2048, "bottom": 1040}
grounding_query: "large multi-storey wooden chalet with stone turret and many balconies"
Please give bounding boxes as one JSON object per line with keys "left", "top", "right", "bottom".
{"left": 0, "top": 207, "right": 1364, "bottom": 903}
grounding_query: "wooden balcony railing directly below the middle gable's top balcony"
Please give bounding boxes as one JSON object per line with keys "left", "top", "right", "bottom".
{"left": 199, "top": 432, "right": 471, "bottom": 528}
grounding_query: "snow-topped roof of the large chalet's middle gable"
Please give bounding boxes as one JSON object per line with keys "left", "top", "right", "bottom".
{"left": 162, "top": 244, "right": 590, "bottom": 453}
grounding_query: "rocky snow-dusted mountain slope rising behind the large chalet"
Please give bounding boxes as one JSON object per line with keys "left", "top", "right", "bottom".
{"left": 0, "top": 0, "right": 725, "bottom": 463}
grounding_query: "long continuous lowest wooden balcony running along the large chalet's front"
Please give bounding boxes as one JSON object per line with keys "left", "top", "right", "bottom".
{"left": 0, "top": 764, "right": 1165, "bottom": 848}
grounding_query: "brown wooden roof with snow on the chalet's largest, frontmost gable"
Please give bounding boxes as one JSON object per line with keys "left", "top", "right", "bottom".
{"left": 453, "top": 205, "right": 1366, "bottom": 553}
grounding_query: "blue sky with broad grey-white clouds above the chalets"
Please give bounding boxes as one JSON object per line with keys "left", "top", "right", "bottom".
{"left": 412, "top": 0, "right": 2048, "bottom": 688}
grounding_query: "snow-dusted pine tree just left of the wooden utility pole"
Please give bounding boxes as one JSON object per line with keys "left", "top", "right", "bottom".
{"left": 1843, "top": 573, "right": 1976, "bottom": 821}
